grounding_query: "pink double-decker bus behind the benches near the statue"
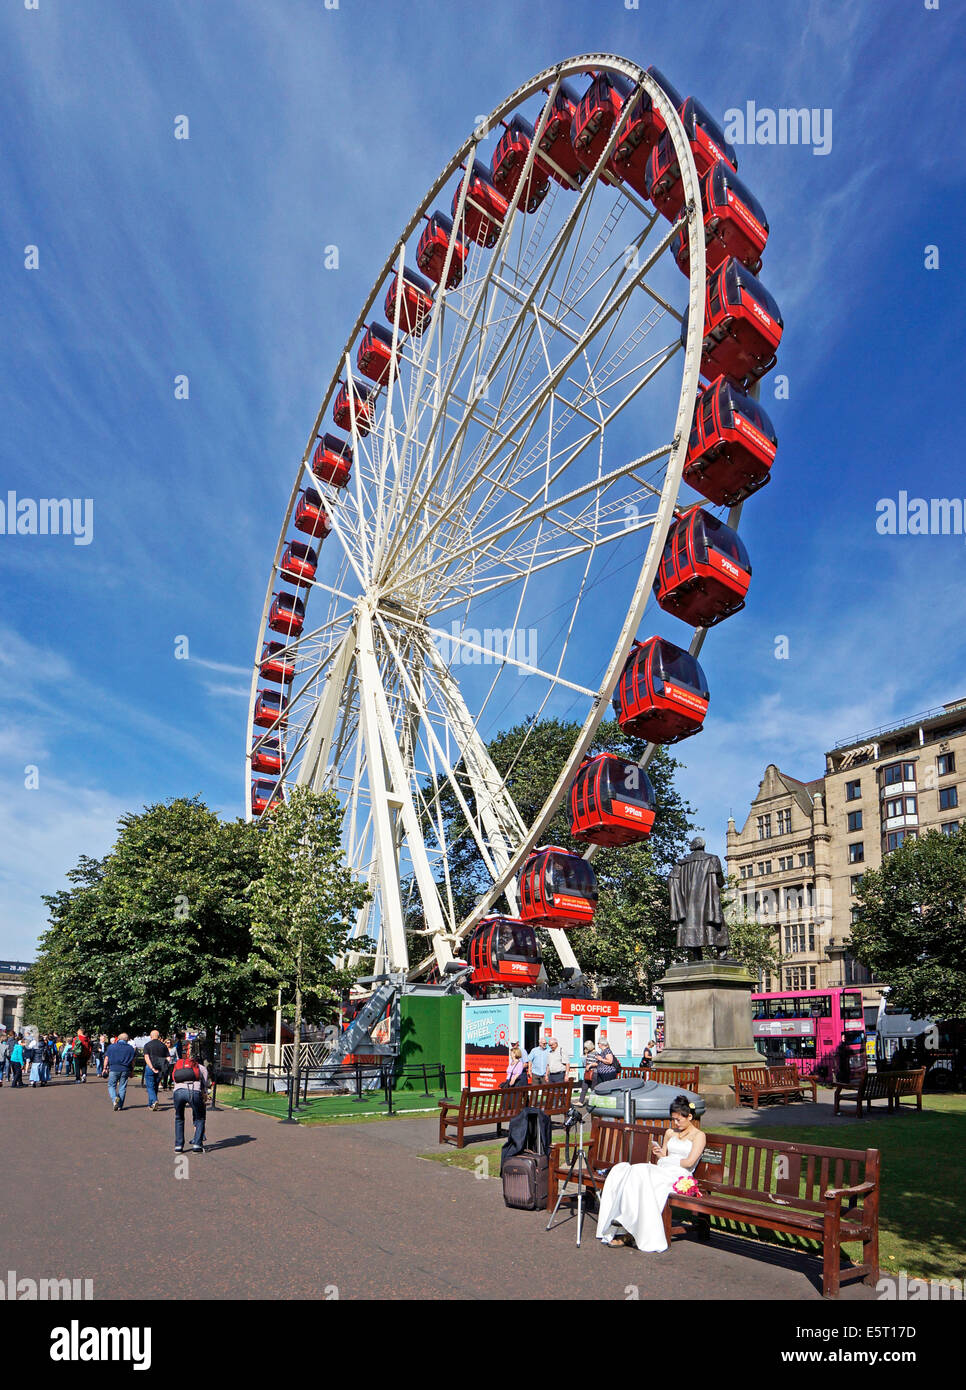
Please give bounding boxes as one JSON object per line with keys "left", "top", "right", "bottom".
{"left": 752, "top": 988, "right": 866, "bottom": 1079}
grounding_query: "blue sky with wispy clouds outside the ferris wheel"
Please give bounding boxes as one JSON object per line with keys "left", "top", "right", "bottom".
{"left": 0, "top": 0, "right": 966, "bottom": 958}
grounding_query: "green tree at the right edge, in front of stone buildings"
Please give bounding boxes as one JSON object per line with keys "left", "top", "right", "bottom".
{"left": 851, "top": 824, "right": 966, "bottom": 1019}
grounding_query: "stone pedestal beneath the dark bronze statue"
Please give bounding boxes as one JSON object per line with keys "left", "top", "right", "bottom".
{"left": 656, "top": 960, "right": 764, "bottom": 1109}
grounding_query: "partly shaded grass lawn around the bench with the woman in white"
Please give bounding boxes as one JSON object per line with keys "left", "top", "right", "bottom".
{"left": 421, "top": 1095, "right": 966, "bottom": 1279}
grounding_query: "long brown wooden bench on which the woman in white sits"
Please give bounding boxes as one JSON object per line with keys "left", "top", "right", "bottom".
{"left": 548, "top": 1116, "right": 880, "bottom": 1298}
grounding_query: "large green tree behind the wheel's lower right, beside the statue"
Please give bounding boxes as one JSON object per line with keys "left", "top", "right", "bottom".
{"left": 407, "top": 719, "right": 692, "bottom": 1002}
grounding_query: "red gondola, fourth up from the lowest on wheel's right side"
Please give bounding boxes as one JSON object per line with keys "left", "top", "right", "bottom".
{"left": 613, "top": 637, "right": 710, "bottom": 744}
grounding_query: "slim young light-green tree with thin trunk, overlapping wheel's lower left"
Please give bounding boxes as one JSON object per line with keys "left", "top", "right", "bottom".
{"left": 250, "top": 787, "right": 370, "bottom": 1094}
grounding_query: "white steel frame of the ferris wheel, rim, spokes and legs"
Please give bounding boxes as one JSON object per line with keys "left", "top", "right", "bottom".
{"left": 245, "top": 53, "right": 717, "bottom": 974}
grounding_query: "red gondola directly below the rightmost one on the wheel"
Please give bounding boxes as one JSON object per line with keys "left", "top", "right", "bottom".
{"left": 684, "top": 377, "right": 778, "bottom": 507}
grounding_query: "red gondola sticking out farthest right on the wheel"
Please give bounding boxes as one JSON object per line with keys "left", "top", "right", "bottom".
{"left": 681, "top": 256, "right": 783, "bottom": 385}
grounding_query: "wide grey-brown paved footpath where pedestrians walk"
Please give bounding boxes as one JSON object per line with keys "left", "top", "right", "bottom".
{"left": 0, "top": 1080, "right": 873, "bottom": 1301}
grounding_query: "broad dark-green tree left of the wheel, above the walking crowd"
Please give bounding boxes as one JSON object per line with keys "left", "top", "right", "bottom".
{"left": 27, "top": 798, "right": 267, "bottom": 1051}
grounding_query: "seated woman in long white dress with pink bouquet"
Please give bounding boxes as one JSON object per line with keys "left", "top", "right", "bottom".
{"left": 598, "top": 1095, "right": 706, "bottom": 1251}
